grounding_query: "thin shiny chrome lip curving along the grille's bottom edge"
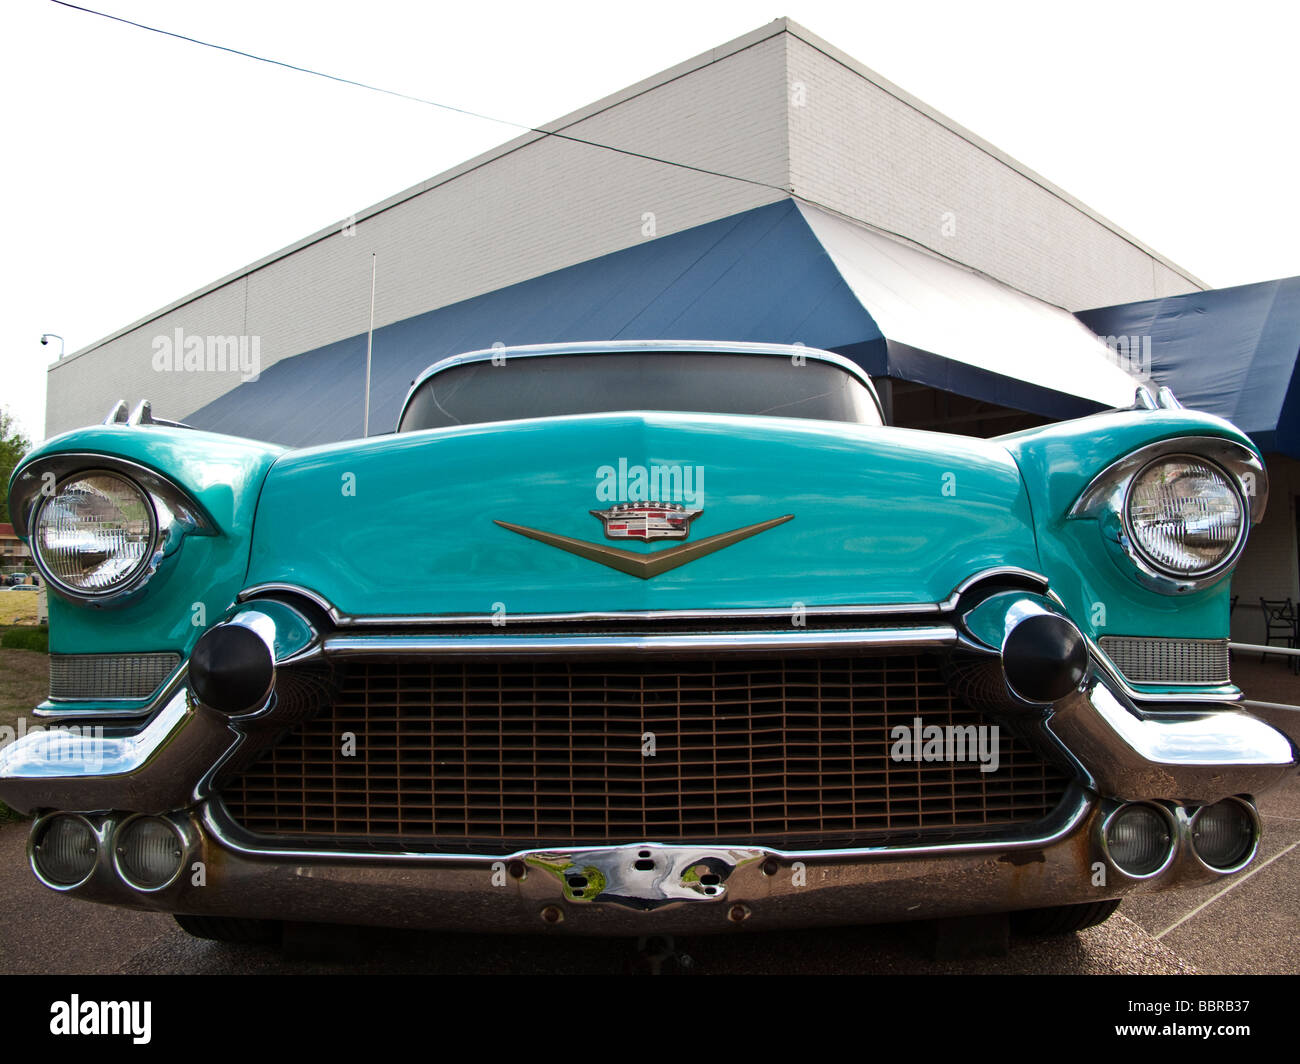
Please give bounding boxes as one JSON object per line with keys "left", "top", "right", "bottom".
{"left": 202, "top": 787, "right": 1092, "bottom": 865}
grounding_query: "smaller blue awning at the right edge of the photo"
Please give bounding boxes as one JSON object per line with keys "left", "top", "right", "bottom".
{"left": 1078, "top": 277, "right": 1300, "bottom": 458}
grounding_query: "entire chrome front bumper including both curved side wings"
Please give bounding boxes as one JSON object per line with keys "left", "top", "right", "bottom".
{"left": 0, "top": 593, "right": 1296, "bottom": 934}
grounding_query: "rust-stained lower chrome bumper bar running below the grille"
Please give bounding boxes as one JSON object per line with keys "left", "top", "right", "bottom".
{"left": 12, "top": 792, "right": 1248, "bottom": 935}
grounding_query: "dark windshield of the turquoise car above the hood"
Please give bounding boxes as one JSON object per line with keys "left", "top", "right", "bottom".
{"left": 398, "top": 351, "right": 880, "bottom": 432}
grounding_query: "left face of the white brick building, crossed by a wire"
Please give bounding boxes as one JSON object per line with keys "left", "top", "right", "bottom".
{"left": 46, "top": 29, "right": 788, "bottom": 436}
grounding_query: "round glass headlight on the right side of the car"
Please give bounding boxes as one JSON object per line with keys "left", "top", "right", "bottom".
{"left": 1127, "top": 455, "right": 1247, "bottom": 576}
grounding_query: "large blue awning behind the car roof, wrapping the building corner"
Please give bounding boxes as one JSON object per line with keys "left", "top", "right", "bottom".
{"left": 185, "top": 199, "right": 1136, "bottom": 446}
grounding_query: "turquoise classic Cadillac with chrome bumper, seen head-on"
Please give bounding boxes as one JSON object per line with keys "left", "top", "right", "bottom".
{"left": 0, "top": 342, "right": 1296, "bottom": 939}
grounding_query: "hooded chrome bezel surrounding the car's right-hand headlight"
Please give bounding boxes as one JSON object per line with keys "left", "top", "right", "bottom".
{"left": 1066, "top": 436, "right": 1269, "bottom": 594}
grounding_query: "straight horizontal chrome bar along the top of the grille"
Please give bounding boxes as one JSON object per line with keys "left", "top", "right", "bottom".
{"left": 322, "top": 624, "right": 957, "bottom": 657}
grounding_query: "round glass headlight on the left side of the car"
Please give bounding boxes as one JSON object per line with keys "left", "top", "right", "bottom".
{"left": 33, "top": 472, "right": 156, "bottom": 596}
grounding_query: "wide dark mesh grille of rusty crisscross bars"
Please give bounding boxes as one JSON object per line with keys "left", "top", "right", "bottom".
{"left": 224, "top": 656, "right": 1069, "bottom": 852}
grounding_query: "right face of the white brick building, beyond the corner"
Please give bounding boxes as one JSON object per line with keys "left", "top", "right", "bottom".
{"left": 787, "top": 27, "right": 1203, "bottom": 311}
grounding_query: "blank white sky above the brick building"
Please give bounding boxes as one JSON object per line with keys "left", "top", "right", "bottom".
{"left": 0, "top": 0, "right": 1300, "bottom": 440}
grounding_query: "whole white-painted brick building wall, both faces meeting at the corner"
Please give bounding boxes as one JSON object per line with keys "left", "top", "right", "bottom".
{"left": 46, "top": 20, "right": 1197, "bottom": 436}
